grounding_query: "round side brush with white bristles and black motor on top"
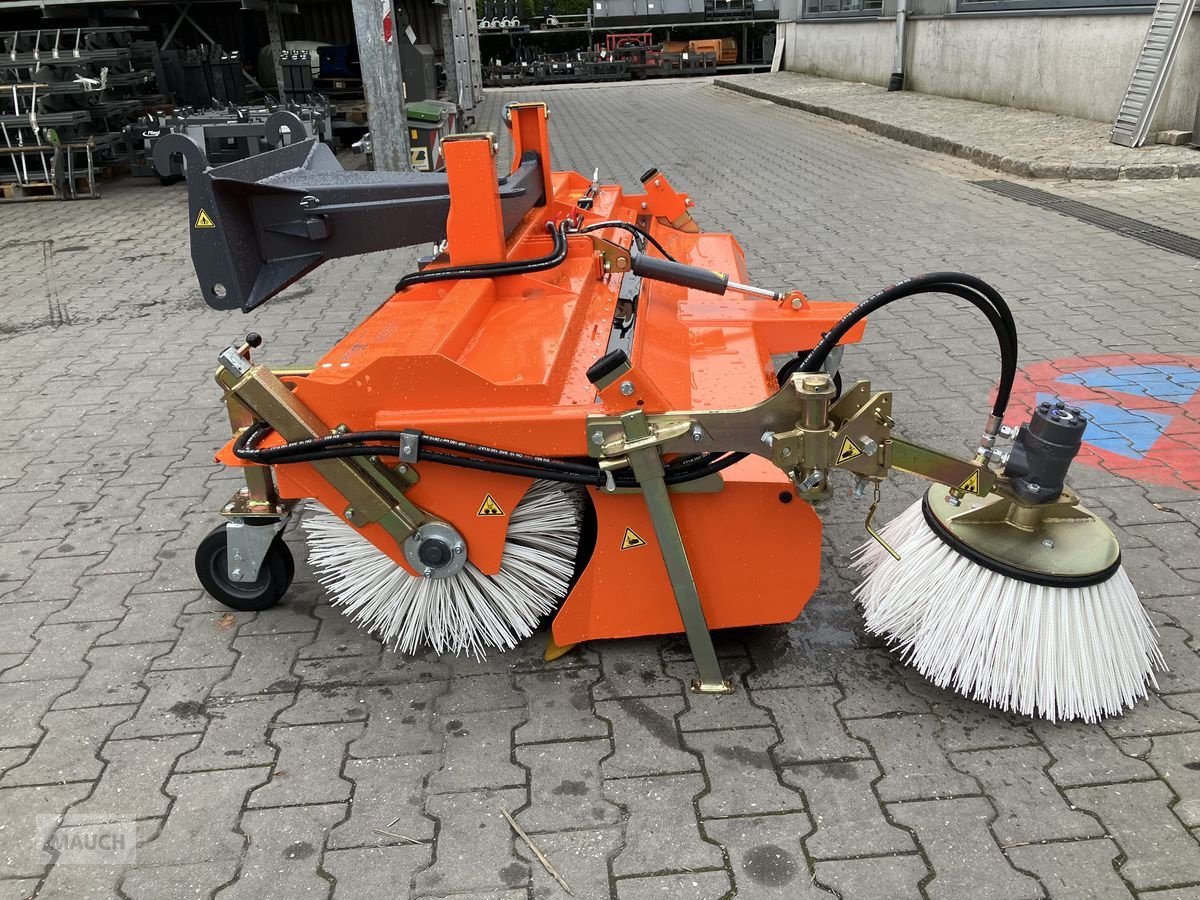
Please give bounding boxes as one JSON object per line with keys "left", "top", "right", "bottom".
{"left": 853, "top": 403, "right": 1165, "bottom": 722}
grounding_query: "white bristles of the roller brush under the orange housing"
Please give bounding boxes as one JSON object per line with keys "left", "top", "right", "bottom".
{"left": 304, "top": 481, "right": 582, "bottom": 658}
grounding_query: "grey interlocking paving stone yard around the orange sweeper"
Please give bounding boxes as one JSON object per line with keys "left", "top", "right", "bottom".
{"left": 0, "top": 82, "right": 1200, "bottom": 900}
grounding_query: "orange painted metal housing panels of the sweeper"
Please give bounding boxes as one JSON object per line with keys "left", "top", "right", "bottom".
{"left": 218, "top": 104, "right": 862, "bottom": 646}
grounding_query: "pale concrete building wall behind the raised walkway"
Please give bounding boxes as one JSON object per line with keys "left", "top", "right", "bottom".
{"left": 785, "top": 14, "right": 1200, "bottom": 131}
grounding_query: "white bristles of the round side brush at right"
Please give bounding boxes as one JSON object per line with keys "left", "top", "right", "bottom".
{"left": 852, "top": 502, "right": 1165, "bottom": 722}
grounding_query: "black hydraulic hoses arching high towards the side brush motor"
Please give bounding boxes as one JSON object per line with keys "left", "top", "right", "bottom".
{"left": 799, "top": 272, "right": 1018, "bottom": 419}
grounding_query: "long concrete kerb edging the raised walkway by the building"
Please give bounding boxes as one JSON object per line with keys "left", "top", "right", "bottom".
{"left": 713, "top": 78, "right": 1185, "bottom": 181}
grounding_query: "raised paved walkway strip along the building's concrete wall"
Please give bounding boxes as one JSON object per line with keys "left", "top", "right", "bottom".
{"left": 715, "top": 72, "right": 1200, "bottom": 181}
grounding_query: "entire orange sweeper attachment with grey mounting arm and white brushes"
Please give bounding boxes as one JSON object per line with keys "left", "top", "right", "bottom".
{"left": 157, "top": 103, "right": 1163, "bottom": 720}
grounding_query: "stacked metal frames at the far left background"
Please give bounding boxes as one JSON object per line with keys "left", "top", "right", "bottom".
{"left": 0, "top": 26, "right": 166, "bottom": 200}
